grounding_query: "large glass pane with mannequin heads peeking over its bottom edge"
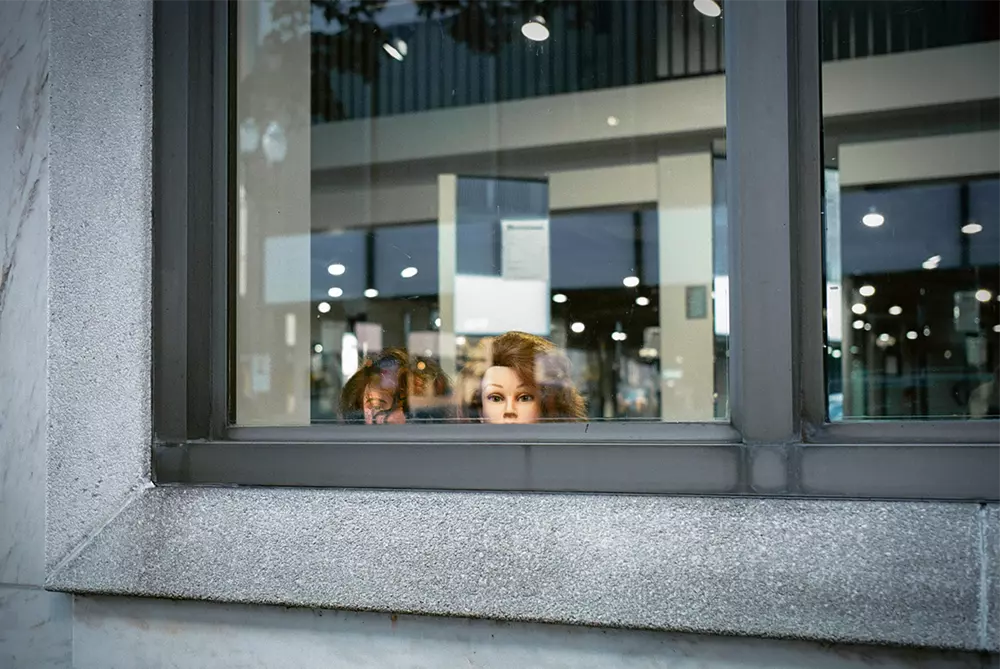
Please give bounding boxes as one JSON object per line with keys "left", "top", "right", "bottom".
{"left": 233, "top": 0, "right": 729, "bottom": 426}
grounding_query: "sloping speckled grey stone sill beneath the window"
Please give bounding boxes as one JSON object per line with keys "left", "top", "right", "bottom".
{"left": 47, "top": 486, "right": 1000, "bottom": 651}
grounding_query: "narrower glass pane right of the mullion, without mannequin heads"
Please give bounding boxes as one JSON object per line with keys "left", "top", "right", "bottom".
{"left": 822, "top": 0, "right": 1000, "bottom": 421}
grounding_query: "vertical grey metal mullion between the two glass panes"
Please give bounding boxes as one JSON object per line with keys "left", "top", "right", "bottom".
{"left": 726, "top": 0, "right": 822, "bottom": 443}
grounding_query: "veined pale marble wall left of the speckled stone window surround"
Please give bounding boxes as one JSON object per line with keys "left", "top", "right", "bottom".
{"left": 0, "top": 0, "right": 72, "bottom": 669}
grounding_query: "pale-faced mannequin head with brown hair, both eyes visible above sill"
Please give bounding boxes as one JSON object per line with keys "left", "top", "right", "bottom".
{"left": 460, "top": 331, "right": 586, "bottom": 423}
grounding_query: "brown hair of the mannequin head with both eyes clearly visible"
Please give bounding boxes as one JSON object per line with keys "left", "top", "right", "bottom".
{"left": 459, "top": 330, "right": 587, "bottom": 422}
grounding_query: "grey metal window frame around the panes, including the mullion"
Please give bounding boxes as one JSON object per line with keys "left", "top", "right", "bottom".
{"left": 153, "top": 0, "right": 1000, "bottom": 501}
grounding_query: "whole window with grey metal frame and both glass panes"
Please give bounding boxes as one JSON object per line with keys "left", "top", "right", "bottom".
{"left": 154, "top": 0, "right": 1000, "bottom": 499}
